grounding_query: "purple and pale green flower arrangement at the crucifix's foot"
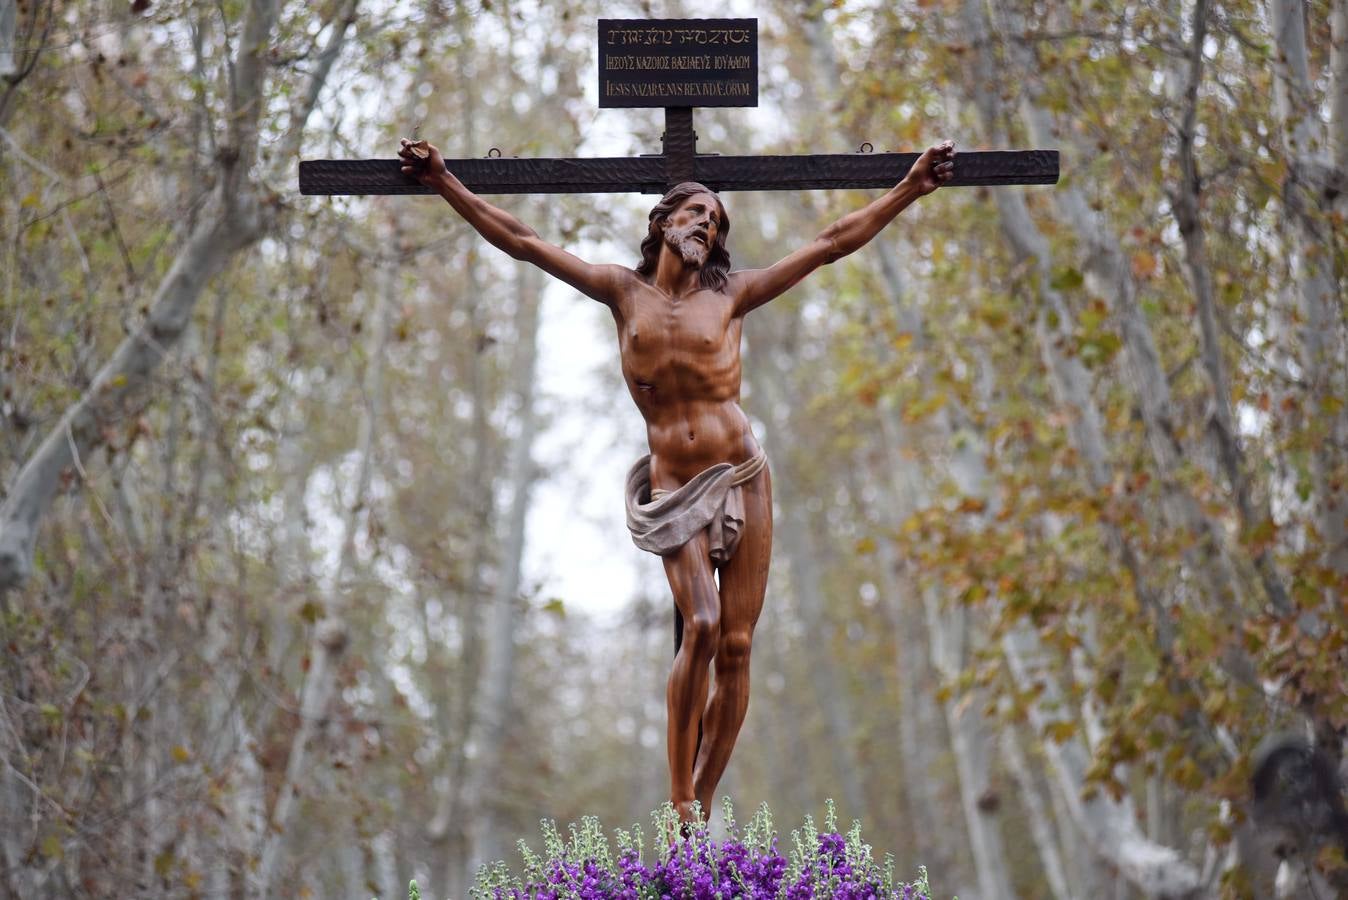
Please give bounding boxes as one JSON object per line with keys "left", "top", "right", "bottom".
{"left": 410, "top": 799, "right": 931, "bottom": 900}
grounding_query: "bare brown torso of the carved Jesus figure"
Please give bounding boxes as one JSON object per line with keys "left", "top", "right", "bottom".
{"left": 611, "top": 275, "right": 759, "bottom": 490}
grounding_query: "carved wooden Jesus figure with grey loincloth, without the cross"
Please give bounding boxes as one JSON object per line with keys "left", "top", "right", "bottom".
{"left": 399, "top": 140, "right": 954, "bottom": 822}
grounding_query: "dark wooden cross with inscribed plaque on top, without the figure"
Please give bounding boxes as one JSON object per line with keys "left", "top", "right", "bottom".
{"left": 299, "top": 19, "right": 1058, "bottom": 195}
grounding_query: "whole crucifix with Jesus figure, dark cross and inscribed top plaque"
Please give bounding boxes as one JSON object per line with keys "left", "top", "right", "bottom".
{"left": 301, "top": 19, "right": 1058, "bottom": 822}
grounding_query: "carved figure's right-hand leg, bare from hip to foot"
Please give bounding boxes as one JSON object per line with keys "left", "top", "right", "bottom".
{"left": 685, "top": 468, "right": 772, "bottom": 816}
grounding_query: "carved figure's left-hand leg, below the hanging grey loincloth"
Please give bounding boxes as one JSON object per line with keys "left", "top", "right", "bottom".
{"left": 665, "top": 534, "right": 721, "bottom": 822}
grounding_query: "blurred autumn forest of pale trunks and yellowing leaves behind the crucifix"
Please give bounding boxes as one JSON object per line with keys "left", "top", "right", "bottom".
{"left": 0, "top": 0, "right": 1348, "bottom": 900}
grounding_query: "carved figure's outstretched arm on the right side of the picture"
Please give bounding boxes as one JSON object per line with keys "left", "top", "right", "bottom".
{"left": 731, "top": 140, "right": 954, "bottom": 315}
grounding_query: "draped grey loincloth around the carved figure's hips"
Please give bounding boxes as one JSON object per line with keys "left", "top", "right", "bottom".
{"left": 627, "top": 453, "right": 767, "bottom": 565}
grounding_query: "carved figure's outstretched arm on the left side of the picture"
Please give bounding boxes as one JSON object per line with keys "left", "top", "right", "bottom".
{"left": 398, "top": 139, "right": 636, "bottom": 304}
